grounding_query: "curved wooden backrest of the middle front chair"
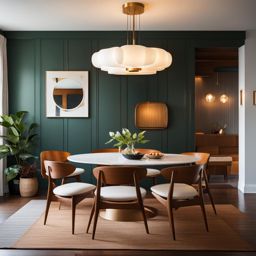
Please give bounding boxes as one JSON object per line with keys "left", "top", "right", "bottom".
{"left": 93, "top": 166, "right": 147, "bottom": 185}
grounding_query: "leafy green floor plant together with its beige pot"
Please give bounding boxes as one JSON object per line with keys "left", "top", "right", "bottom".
{"left": 0, "top": 111, "right": 38, "bottom": 196}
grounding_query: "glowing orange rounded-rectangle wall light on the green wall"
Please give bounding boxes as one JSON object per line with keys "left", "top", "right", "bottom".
{"left": 135, "top": 102, "right": 168, "bottom": 130}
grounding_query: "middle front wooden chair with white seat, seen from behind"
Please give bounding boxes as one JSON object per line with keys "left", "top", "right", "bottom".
{"left": 86, "top": 166, "right": 149, "bottom": 239}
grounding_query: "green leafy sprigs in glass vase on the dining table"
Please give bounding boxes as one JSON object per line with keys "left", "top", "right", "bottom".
{"left": 106, "top": 128, "right": 149, "bottom": 158}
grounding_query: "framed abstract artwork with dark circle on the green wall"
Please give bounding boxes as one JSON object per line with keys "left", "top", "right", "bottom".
{"left": 46, "top": 71, "right": 89, "bottom": 118}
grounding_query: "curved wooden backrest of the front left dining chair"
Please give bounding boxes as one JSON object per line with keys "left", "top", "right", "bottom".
{"left": 44, "top": 160, "right": 76, "bottom": 179}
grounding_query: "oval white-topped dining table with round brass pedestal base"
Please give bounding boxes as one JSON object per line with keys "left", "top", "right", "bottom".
{"left": 68, "top": 153, "right": 199, "bottom": 221}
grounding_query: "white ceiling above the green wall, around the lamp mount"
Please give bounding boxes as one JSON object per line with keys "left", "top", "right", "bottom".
{"left": 0, "top": 0, "right": 256, "bottom": 30}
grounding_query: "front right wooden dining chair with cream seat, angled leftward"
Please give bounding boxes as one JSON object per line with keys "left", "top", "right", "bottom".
{"left": 151, "top": 165, "right": 208, "bottom": 240}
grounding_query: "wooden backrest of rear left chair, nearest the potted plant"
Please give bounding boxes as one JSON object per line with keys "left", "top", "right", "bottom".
{"left": 40, "top": 150, "right": 70, "bottom": 179}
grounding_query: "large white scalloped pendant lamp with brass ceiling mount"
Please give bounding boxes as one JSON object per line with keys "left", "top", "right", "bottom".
{"left": 92, "top": 2, "right": 172, "bottom": 75}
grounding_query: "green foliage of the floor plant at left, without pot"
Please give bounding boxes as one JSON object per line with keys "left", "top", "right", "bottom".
{"left": 0, "top": 111, "right": 38, "bottom": 181}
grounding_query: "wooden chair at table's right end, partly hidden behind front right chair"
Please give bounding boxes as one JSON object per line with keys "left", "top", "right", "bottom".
{"left": 182, "top": 152, "right": 217, "bottom": 214}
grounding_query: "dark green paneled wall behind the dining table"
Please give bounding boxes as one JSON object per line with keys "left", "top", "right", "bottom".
{"left": 5, "top": 32, "right": 245, "bottom": 186}
